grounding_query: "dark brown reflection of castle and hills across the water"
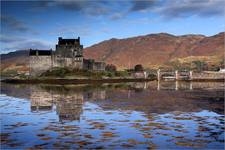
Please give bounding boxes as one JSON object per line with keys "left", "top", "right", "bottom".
{"left": 1, "top": 81, "right": 224, "bottom": 122}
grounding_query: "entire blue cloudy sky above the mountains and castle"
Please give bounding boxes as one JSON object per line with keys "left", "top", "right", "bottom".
{"left": 0, "top": 0, "right": 225, "bottom": 54}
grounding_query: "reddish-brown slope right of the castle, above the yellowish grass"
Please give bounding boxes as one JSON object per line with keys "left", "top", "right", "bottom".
{"left": 84, "top": 33, "right": 224, "bottom": 68}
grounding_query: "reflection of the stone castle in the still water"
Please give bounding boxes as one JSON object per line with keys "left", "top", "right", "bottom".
{"left": 29, "top": 86, "right": 106, "bottom": 122}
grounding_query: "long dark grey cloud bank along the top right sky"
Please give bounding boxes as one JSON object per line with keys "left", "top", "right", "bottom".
{"left": 130, "top": 0, "right": 225, "bottom": 19}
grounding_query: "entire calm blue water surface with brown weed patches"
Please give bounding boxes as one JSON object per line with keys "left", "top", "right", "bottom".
{"left": 0, "top": 82, "right": 224, "bottom": 149}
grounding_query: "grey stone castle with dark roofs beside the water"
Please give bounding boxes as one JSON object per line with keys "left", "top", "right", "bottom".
{"left": 29, "top": 37, "right": 105, "bottom": 76}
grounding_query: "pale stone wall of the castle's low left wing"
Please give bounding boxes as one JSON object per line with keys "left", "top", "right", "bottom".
{"left": 29, "top": 55, "right": 52, "bottom": 76}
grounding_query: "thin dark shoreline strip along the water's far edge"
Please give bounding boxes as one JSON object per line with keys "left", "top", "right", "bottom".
{"left": 1, "top": 78, "right": 225, "bottom": 85}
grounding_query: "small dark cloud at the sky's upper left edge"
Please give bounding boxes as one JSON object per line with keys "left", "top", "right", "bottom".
{"left": 1, "top": 15, "right": 30, "bottom": 32}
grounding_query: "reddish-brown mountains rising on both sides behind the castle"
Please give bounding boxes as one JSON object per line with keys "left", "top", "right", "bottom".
{"left": 1, "top": 32, "right": 225, "bottom": 72}
